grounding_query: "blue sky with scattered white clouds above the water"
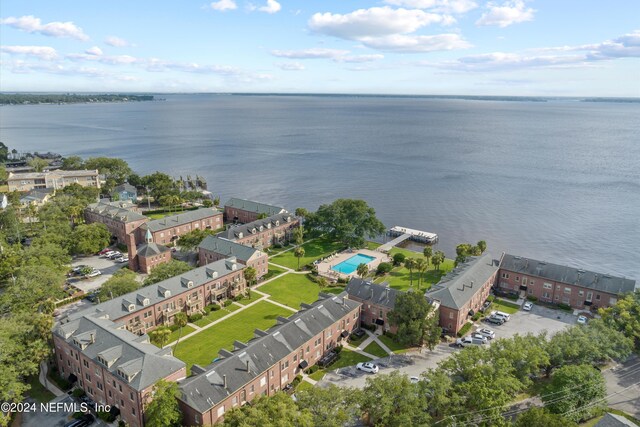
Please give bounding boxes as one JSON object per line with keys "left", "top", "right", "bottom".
{"left": 0, "top": 0, "right": 640, "bottom": 97}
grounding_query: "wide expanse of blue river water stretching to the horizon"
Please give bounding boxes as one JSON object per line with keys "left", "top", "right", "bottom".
{"left": 0, "top": 95, "right": 640, "bottom": 280}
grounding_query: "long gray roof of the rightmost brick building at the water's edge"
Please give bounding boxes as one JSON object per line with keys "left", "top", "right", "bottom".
{"left": 500, "top": 254, "right": 636, "bottom": 294}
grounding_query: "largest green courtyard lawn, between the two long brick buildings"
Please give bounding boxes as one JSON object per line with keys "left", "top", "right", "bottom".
{"left": 174, "top": 301, "right": 292, "bottom": 370}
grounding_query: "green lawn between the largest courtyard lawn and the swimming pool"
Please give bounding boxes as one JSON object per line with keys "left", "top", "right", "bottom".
{"left": 258, "top": 273, "right": 328, "bottom": 310}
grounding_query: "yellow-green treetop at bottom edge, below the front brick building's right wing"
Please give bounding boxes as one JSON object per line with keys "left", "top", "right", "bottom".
{"left": 223, "top": 392, "right": 314, "bottom": 427}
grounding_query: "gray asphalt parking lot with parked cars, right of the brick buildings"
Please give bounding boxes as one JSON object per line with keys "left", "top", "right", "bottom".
{"left": 318, "top": 305, "right": 577, "bottom": 388}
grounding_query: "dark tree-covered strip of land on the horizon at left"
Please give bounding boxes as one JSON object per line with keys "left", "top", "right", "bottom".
{"left": 0, "top": 93, "right": 154, "bottom": 105}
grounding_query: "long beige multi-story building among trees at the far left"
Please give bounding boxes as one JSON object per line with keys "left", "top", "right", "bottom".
{"left": 7, "top": 169, "right": 100, "bottom": 191}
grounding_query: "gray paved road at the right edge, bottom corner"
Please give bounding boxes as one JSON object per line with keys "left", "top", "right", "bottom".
{"left": 603, "top": 355, "right": 640, "bottom": 419}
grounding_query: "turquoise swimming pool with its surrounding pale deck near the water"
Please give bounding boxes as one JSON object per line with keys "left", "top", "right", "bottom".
{"left": 317, "top": 249, "right": 390, "bottom": 282}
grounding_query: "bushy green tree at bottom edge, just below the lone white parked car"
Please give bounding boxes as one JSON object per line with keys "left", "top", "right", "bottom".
{"left": 358, "top": 371, "right": 430, "bottom": 427}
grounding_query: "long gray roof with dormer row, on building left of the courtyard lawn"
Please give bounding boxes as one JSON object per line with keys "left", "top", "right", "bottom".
{"left": 70, "top": 258, "right": 244, "bottom": 320}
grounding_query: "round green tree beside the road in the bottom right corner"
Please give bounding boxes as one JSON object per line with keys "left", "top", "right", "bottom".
{"left": 542, "top": 365, "right": 607, "bottom": 422}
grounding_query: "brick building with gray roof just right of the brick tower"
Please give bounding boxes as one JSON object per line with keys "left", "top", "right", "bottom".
{"left": 136, "top": 208, "right": 223, "bottom": 245}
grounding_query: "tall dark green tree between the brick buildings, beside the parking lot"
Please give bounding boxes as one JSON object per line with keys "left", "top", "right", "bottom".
{"left": 387, "top": 291, "right": 442, "bottom": 345}
